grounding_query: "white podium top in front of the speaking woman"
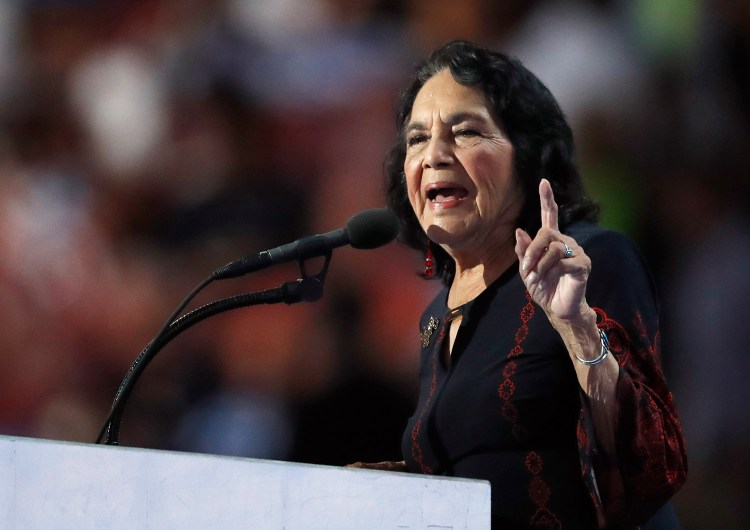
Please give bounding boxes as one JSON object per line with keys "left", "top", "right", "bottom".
{"left": 0, "top": 436, "right": 490, "bottom": 530}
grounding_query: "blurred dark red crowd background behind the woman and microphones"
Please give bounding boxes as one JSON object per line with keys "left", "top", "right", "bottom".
{"left": 0, "top": 0, "right": 750, "bottom": 530}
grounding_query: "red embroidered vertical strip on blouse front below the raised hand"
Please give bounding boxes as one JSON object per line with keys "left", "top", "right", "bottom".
{"left": 497, "top": 291, "right": 561, "bottom": 530}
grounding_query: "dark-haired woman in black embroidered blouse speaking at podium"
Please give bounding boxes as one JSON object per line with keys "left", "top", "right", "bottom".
{"left": 355, "top": 42, "right": 686, "bottom": 530}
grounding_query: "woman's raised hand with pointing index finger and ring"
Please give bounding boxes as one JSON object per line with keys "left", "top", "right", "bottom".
{"left": 515, "top": 179, "right": 591, "bottom": 321}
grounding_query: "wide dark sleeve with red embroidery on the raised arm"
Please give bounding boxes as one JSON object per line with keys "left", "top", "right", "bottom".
{"left": 578, "top": 231, "right": 687, "bottom": 524}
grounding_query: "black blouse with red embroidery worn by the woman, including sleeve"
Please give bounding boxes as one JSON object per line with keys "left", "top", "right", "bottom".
{"left": 402, "top": 223, "right": 685, "bottom": 530}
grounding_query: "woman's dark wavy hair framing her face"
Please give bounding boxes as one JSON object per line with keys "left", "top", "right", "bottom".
{"left": 385, "top": 41, "right": 599, "bottom": 284}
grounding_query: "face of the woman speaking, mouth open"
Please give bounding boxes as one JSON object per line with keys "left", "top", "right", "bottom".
{"left": 404, "top": 69, "right": 524, "bottom": 257}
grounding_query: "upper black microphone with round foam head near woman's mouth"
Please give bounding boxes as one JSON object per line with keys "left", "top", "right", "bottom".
{"left": 212, "top": 208, "right": 398, "bottom": 280}
